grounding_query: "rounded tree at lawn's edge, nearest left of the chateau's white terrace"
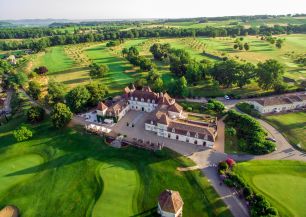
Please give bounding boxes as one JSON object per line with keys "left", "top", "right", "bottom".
{"left": 51, "top": 103, "right": 72, "bottom": 128}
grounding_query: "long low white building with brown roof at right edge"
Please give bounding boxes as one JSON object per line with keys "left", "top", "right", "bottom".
{"left": 248, "top": 94, "right": 306, "bottom": 114}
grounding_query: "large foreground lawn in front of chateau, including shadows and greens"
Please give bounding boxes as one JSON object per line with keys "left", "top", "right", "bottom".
{"left": 0, "top": 113, "right": 231, "bottom": 217}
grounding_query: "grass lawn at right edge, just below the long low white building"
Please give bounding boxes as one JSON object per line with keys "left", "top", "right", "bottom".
{"left": 265, "top": 112, "right": 306, "bottom": 150}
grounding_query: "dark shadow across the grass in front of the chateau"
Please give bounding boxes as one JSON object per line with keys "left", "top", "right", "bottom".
{"left": 6, "top": 124, "right": 179, "bottom": 176}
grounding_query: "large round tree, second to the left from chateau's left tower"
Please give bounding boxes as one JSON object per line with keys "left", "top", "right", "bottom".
{"left": 66, "top": 86, "right": 90, "bottom": 112}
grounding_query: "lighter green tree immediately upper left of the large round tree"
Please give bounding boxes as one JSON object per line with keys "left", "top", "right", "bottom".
{"left": 46, "top": 81, "right": 65, "bottom": 105}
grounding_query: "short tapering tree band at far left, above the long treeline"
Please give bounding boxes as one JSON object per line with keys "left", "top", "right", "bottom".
{"left": 0, "top": 28, "right": 67, "bottom": 39}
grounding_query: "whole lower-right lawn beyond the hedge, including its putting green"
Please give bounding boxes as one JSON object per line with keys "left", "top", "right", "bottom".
{"left": 235, "top": 161, "right": 306, "bottom": 217}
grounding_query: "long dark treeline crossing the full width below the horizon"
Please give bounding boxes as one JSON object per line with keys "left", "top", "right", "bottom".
{"left": 0, "top": 24, "right": 306, "bottom": 51}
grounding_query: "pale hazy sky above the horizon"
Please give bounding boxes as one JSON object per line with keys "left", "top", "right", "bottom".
{"left": 0, "top": 0, "right": 306, "bottom": 20}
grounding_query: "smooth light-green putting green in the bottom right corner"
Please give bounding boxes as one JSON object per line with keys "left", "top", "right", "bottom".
{"left": 252, "top": 174, "right": 306, "bottom": 216}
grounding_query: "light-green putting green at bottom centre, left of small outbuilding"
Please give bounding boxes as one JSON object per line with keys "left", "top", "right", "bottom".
{"left": 92, "top": 161, "right": 140, "bottom": 217}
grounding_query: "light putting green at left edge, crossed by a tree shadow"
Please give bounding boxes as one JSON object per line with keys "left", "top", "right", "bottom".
{"left": 0, "top": 154, "right": 43, "bottom": 195}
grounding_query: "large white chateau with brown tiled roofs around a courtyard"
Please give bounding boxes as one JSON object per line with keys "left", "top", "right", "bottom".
{"left": 97, "top": 87, "right": 217, "bottom": 147}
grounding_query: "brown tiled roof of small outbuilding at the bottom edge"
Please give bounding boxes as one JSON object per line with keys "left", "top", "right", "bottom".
{"left": 158, "top": 190, "right": 184, "bottom": 213}
